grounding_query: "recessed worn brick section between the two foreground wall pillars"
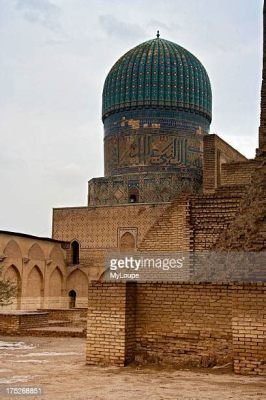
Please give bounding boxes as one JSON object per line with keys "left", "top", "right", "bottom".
{"left": 136, "top": 283, "right": 232, "bottom": 366}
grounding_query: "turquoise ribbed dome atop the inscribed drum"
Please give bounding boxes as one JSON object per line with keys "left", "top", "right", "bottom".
{"left": 102, "top": 38, "right": 212, "bottom": 121}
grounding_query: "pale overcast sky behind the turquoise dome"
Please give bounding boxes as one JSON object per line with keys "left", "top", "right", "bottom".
{"left": 0, "top": 0, "right": 262, "bottom": 236}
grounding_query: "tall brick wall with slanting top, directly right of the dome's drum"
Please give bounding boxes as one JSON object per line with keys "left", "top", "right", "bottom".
{"left": 203, "top": 134, "right": 247, "bottom": 193}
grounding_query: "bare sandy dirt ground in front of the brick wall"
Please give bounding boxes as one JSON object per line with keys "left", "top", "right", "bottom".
{"left": 0, "top": 336, "right": 266, "bottom": 400}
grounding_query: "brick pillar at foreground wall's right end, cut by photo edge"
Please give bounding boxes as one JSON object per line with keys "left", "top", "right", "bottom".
{"left": 232, "top": 283, "right": 266, "bottom": 375}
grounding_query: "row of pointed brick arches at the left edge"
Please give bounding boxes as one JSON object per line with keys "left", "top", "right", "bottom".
{"left": 0, "top": 232, "right": 88, "bottom": 310}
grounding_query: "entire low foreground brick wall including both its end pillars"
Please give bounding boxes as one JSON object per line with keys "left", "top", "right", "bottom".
{"left": 87, "top": 282, "right": 266, "bottom": 374}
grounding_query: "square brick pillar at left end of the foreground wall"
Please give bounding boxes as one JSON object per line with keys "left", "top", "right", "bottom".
{"left": 86, "top": 282, "right": 136, "bottom": 366}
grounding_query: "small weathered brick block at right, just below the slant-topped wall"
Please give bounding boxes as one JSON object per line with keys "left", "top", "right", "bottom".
{"left": 220, "top": 160, "right": 258, "bottom": 186}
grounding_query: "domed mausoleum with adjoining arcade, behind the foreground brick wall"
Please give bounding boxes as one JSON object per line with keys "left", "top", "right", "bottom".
{"left": 0, "top": 34, "right": 264, "bottom": 309}
